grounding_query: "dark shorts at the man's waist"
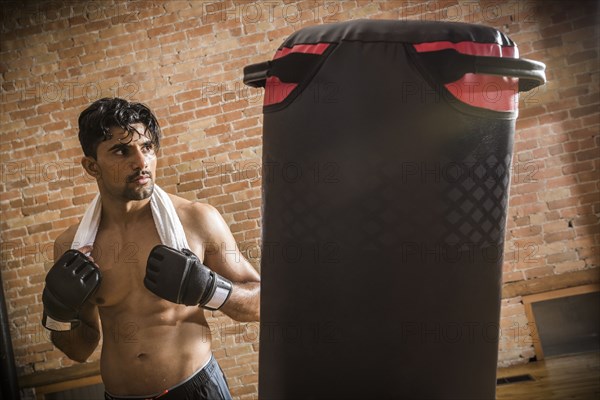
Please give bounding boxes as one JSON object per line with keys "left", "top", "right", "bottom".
{"left": 104, "top": 356, "right": 231, "bottom": 400}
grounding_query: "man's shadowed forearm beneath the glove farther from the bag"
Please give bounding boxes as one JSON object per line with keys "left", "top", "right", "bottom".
{"left": 50, "top": 321, "right": 100, "bottom": 362}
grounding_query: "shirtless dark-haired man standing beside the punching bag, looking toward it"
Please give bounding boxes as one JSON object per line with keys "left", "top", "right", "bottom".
{"left": 44, "top": 98, "right": 260, "bottom": 400}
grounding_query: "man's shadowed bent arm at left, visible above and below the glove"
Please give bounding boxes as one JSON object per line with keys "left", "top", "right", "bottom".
{"left": 50, "top": 231, "right": 100, "bottom": 362}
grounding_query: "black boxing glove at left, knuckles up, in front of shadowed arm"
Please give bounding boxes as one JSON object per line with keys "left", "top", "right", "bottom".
{"left": 42, "top": 250, "right": 102, "bottom": 331}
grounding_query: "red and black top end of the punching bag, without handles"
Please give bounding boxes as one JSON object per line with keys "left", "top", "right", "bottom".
{"left": 264, "top": 20, "right": 519, "bottom": 112}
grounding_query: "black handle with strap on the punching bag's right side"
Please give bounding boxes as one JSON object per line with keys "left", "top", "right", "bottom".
{"left": 416, "top": 49, "right": 546, "bottom": 92}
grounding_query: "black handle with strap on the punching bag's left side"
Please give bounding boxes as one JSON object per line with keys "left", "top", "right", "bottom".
{"left": 244, "top": 53, "right": 321, "bottom": 87}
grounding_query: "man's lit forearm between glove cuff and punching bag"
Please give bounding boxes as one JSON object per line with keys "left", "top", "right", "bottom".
{"left": 221, "top": 282, "right": 260, "bottom": 322}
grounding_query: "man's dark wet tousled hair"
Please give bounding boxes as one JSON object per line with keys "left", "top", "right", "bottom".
{"left": 79, "top": 97, "right": 161, "bottom": 158}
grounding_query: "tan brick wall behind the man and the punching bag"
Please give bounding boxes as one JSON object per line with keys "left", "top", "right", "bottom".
{"left": 0, "top": 0, "right": 600, "bottom": 399}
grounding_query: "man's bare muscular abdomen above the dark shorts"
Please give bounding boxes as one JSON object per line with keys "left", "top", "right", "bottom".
{"left": 101, "top": 305, "right": 211, "bottom": 396}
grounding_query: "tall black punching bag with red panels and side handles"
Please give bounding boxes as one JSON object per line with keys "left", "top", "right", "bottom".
{"left": 244, "top": 20, "right": 545, "bottom": 400}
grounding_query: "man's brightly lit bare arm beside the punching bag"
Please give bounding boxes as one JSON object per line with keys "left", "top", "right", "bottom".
{"left": 196, "top": 204, "right": 260, "bottom": 322}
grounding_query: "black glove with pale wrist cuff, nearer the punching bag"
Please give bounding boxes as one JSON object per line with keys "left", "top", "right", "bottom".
{"left": 144, "top": 244, "right": 233, "bottom": 310}
